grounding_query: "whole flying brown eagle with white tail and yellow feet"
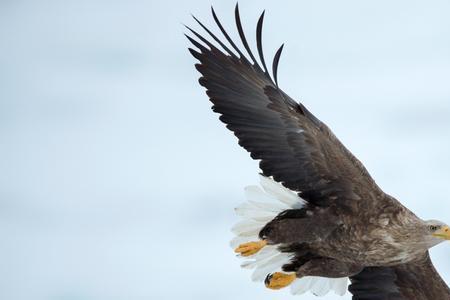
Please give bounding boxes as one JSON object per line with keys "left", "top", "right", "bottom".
{"left": 186, "top": 5, "right": 450, "bottom": 300}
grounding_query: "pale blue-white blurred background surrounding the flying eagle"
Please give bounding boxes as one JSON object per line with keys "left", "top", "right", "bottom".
{"left": 0, "top": 0, "right": 450, "bottom": 300}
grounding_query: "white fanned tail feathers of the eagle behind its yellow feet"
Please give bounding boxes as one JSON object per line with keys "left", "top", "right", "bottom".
{"left": 230, "top": 175, "right": 348, "bottom": 296}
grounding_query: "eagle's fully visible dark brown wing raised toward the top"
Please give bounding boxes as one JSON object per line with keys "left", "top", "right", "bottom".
{"left": 187, "top": 6, "right": 385, "bottom": 207}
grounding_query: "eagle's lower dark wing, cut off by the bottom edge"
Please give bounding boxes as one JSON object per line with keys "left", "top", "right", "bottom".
{"left": 349, "top": 253, "right": 450, "bottom": 300}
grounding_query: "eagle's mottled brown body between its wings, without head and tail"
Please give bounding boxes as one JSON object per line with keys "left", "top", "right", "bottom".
{"left": 260, "top": 196, "right": 428, "bottom": 266}
